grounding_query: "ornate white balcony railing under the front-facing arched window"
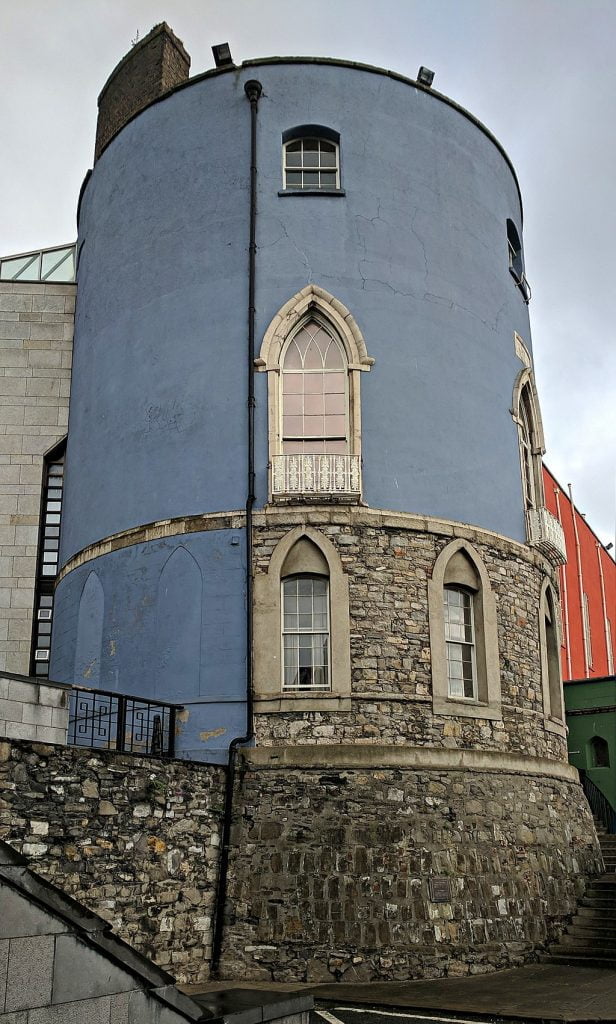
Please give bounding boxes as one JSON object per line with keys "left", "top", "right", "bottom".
{"left": 271, "top": 455, "right": 361, "bottom": 495}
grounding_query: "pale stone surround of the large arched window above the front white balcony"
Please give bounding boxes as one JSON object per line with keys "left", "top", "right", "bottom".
{"left": 255, "top": 285, "right": 375, "bottom": 501}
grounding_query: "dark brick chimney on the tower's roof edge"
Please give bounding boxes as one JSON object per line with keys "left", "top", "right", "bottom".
{"left": 94, "top": 22, "right": 190, "bottom": 160}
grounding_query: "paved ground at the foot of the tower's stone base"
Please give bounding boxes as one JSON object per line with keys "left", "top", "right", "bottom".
{"left": 178, "top": 964, "right": 616, "bottom": 1024}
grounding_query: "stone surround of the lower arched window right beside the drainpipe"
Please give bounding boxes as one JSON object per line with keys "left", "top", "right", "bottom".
{"left": 253, "top": 525, "right": 351, "bottom": 714}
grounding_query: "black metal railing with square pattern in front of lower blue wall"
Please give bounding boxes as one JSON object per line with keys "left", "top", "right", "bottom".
{"left": 69, "top": 686, "right": 180, "bottom": 758}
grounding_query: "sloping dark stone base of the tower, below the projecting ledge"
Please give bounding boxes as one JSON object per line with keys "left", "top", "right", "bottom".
{"left": 222, "top": 758, "right": 601, "bottom": 982}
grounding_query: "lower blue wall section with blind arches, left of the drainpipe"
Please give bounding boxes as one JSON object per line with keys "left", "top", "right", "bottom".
{"left": 50, "top": 530, "right": 246, "bottom": 760}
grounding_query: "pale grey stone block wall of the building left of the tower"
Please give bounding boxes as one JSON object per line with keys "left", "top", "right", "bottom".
{"left": 0, "top": 282, "right": 76, "bottom": 674}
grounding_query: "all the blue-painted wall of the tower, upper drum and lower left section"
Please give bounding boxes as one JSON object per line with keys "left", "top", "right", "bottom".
{"left": 51, "top": 62, "right": 530, "bottom": 756}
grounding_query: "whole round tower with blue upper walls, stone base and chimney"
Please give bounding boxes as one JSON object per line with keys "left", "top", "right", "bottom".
{"left": 51, "top": 25, "right": 599, "bottom": 980}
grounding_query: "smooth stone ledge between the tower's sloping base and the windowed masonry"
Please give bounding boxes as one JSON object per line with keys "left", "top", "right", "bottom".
{"left": 240, "top": 743, "right": 579, "bottom": 783}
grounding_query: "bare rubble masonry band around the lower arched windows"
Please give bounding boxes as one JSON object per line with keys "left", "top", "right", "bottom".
{"left": 255, "top": 508, "right": 567, "bottom": 760}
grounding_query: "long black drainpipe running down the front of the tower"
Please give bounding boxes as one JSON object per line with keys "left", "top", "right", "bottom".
{"left": 212, "top": 79, "right": 263, "bottom": 977}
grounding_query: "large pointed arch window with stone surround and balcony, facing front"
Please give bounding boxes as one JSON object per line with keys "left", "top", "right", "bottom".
{"left": 256, "top": 285, "right": 375, "bottom": 501}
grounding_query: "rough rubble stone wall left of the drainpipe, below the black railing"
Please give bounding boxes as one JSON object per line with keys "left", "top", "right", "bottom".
{"left": 0, "top": 741, "right": 224, "bottom": 982}
